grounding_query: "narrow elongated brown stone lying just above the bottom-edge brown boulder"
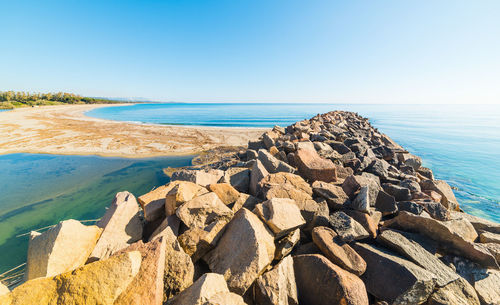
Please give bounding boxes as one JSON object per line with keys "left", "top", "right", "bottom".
{"left": 312, "top": 227, "right": 366, "bottom": 275}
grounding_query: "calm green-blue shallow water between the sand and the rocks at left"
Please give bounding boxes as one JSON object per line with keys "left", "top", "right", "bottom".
{"left": 0, "top": 154, "right": 192, "bottom": 274}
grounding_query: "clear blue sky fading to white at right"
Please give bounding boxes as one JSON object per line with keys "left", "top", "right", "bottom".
{"left": 0, "top": 0, "right": 500, "bottom": 103}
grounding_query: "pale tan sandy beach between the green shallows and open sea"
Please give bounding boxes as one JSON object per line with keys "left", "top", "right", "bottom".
{"left": 0, "top": 105, "right": 266, "bottom": 158}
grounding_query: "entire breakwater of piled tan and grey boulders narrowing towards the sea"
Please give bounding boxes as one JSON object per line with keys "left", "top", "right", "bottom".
{"left": 0, "top": 112, "right": 500, "bottom": 305}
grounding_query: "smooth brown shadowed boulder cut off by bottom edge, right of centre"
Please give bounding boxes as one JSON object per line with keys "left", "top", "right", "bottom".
{"left": 293, "top": 254, "right": 368, "bottom": 305}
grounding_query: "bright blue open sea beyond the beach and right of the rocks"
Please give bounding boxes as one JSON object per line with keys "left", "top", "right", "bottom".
{"left": 87, "top": 103, "right": 500, "bottom": 222}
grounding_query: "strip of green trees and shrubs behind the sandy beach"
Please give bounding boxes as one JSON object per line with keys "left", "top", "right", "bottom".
{"left": 0, "top": 91, "right": 123, "bottom": 109}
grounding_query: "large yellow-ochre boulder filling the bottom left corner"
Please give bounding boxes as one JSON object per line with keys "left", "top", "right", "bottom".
{"left": 0, "top": 251, "right": 141, "bottom": 305}
